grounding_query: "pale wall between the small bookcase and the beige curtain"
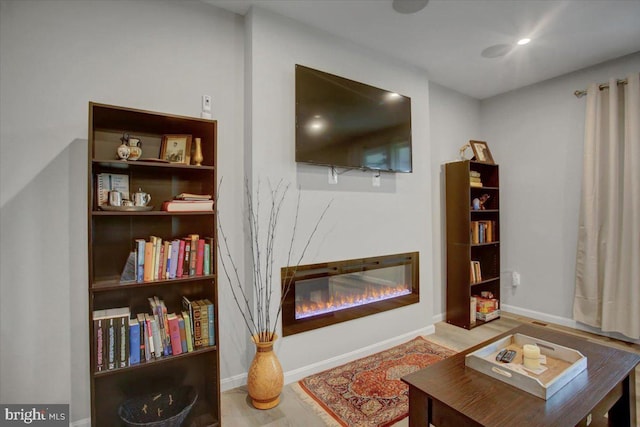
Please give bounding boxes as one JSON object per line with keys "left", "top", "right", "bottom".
{"left": 480, "top": 53, "right": 640, "bottom": 326}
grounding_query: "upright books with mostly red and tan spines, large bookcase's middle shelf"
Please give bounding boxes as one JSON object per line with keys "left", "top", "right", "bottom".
{"left": 134, "top": 234, "right": 214, "bottom": 282}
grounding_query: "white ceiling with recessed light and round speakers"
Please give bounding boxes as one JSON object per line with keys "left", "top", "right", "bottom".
{"left": 202, "top": 0, "right": 640, "bottom": 99}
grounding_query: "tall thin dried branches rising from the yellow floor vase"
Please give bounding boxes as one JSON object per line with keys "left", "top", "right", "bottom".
{"left": 217, "top": 179, "right": 331, "bottom": 342}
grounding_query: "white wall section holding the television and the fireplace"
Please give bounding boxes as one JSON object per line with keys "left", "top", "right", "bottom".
{"left": 242, "top": 8, "right": 434, "bottom": 380}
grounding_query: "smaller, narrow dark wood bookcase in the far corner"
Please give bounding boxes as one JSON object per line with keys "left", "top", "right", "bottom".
{"left": 445, "top": 160, "right": 500, "bottom": 329}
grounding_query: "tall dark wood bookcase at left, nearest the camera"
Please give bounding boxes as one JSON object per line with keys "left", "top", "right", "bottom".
{"left": 87, "top": 102, "right": 221, "bottom": 426}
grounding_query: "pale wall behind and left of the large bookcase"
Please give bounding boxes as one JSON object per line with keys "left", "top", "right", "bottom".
{"left": 0, "top": 0, "right": 246, "bottom": 420}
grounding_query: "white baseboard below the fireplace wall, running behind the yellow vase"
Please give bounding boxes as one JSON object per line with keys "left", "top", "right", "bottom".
{"left": 220, "top": 325, "right": 436, "bottom": 392}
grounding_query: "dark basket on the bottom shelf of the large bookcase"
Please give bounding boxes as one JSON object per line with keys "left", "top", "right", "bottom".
{"left": 118, "top": 386, "right": 198, "bottom": 427}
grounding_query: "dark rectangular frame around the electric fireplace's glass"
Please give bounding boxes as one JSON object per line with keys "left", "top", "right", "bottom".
{"left": 280, "top": 252, "right": 420, "bottom": 337}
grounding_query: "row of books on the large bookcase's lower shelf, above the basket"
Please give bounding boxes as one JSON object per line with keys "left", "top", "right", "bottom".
{"left": 93, "top": 297, "right": 215, "bottom": 372}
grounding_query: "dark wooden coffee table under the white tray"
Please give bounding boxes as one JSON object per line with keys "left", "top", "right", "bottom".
{"left": 402, "top": 325, "right": 640, "bottom": 427}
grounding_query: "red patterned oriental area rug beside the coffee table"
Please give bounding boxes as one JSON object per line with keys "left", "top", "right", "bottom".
{"left": 298, "top": 337, "right": 456, "bottom": 427}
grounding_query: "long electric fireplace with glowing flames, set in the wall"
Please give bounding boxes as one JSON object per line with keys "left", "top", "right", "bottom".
{"left": 281, "top": 252, "right": 420, "bottom": 336}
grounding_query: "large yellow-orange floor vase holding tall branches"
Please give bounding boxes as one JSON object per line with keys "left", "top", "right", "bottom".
{"left": 247, "top": 335, "right": 284, "bottom": 409}
